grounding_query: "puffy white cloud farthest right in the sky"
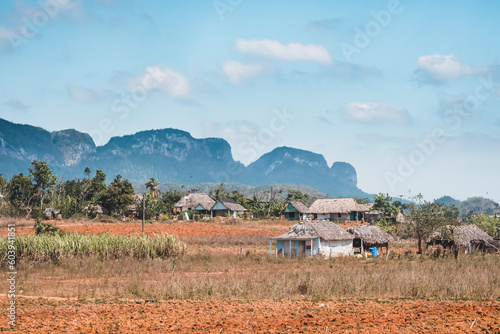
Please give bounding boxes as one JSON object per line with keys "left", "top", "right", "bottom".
{"left": 417, "top": 55, "right": 488, "bottom": 83}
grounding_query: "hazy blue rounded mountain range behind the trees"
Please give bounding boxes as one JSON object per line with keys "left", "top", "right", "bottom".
{"left": 0, "top": 118, "right": 371, "bottom": 197}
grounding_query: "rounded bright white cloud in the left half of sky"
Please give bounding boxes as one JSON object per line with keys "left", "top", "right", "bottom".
{"left": 129, "top": 65, "right": 191, "bottom": 97}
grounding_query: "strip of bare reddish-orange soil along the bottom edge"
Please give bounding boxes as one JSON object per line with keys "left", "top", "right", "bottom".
{"left": 0, "top": 297, "right": 500, "bottom": 333}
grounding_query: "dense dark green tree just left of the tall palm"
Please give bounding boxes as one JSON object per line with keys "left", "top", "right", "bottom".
{"left": 102, "top": 174, "right": 134, "bottom": 216}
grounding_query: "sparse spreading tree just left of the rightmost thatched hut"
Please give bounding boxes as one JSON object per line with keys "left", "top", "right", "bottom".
{"left": 400, "top": 194, "right": 459, "bottom": 254}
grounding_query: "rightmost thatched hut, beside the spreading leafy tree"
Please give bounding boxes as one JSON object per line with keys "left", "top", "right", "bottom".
{"left": 426, "top": 224, "right": 493, "bottom": 254}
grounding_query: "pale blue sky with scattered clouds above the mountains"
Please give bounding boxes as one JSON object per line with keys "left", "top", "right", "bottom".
{"left": 0, "top": 0, "right": 500, "bottom": 202}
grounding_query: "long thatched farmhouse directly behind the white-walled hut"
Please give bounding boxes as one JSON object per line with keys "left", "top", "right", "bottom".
{"left": 309, "top": 198, "right": 367, "bottom": 222}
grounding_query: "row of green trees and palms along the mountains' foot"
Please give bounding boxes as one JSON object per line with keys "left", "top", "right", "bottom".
{"left": 0, "top": 161, "right": 316, "bottom": 219}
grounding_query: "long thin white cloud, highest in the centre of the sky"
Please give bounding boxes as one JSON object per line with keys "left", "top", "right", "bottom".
{"left": 236, "top": 38, "right": 332, "bottom": 65}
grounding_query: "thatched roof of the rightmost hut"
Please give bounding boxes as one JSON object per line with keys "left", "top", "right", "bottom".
{"left": 427, "top": 224, "right": 493, "bottom": 246}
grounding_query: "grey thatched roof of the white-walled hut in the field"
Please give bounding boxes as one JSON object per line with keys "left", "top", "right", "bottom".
{"left": 273, "top": 220, "right": 354, "bottom": 241}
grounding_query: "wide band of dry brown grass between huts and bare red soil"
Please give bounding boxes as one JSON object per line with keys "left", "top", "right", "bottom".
{"left": 10, "top": 247, "right": 500, "bottom": 300}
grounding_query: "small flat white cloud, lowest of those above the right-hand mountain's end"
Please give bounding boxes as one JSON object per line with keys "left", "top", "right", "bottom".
{"left": 339, "top": 102, "right": 410, "bottom": 124}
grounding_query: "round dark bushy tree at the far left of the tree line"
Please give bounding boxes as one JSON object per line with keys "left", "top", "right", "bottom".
{"left": 7, "top": 173, "right": 36, "bottom": 218}
